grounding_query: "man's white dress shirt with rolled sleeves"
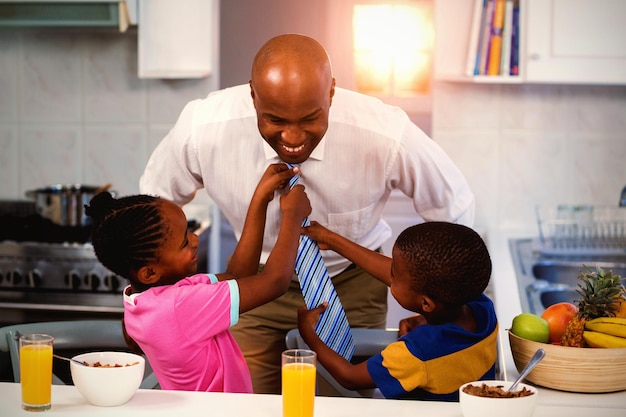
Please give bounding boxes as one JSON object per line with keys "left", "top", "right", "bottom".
{"left": 140, "top": 84, "right": 474, "bottom": 276}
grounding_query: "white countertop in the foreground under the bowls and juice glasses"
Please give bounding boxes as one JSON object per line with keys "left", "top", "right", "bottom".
{"left": 0, "top": 382, "right": 624, "bottom": 417}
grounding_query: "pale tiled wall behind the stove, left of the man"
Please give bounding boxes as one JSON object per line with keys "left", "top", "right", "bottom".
{"left": 0, "top": 29, "right": 217, "bottom": 199}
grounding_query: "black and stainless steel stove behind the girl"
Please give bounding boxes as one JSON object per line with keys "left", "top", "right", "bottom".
{"left": 0, "top": 200, "right": 127, "bottom": 325}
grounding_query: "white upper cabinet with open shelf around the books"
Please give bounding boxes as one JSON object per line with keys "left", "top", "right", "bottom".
{"left": 435, "top": 0, "right": 626, "bottom": 85}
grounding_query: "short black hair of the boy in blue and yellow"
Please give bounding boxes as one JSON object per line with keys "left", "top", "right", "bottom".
{"left": 395, "top": 222, "right": 491, "bottom": 307}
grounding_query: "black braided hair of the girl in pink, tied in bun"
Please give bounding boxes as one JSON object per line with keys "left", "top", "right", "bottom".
{"left": 85, "top": 192, "right": 167, "bottom": 286}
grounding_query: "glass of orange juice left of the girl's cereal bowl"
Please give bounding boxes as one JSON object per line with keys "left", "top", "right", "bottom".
{"left": 20, "top": 334, "right": 54, "bottom": 411}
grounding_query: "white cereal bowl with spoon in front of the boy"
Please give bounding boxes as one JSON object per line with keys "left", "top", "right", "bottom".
{"left": 459, "top": 381, "right": 537, "bottom": 417}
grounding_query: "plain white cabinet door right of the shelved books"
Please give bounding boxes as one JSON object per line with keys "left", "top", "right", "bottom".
{"left": 525, "top": 0, "right": 626, "bottom": 84}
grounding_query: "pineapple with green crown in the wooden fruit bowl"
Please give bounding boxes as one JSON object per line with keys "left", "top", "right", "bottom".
{"left": 561, "top": 265, "right": 624, "bottom": 347}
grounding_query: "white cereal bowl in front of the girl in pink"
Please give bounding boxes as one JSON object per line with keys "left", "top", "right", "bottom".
{"left": 70, "top": 352, "right": 146, "bottom": 407}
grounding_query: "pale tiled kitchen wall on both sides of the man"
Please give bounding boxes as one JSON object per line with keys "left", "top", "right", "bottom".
{"left": 0, "top": 29, "right": 626, "bottom": 234}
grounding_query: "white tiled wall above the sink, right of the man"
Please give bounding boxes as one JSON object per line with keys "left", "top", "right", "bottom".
{"left": 433, "top": 82, "right": 626, "bottom": 231}
